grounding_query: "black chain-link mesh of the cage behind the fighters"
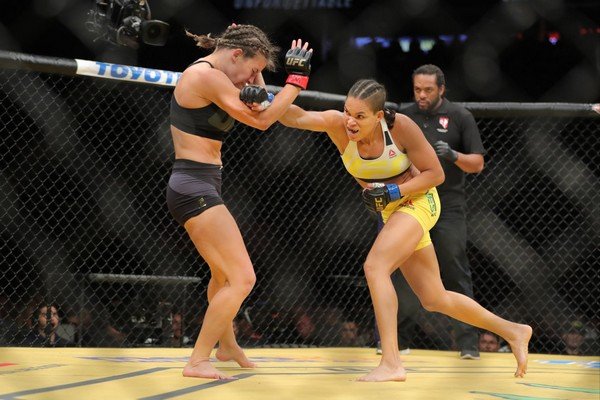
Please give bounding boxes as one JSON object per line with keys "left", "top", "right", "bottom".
{"left": 0, "top": 71, "right": 600, "bottom": 354}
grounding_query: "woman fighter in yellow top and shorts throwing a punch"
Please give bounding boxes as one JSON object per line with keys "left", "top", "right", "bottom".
{"left": 242, "top": 80, "right": 532, "bottom": 381}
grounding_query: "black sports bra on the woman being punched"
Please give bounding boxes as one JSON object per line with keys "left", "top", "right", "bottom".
{"left": 170, "top": 60, "right": 235, "bottom": 141}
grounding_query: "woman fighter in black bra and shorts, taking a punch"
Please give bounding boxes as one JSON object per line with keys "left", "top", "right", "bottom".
{"left": 167, "top": 25, "right": 312, "bottom": 379}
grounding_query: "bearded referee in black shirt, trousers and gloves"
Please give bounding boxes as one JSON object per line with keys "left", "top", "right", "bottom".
{"left": 392, "top": 64, "right": 485, "bottom": 359}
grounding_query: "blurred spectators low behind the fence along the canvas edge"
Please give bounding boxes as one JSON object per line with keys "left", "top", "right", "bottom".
{"left": 0, "top": 295, "right": 600, "bottom": 355}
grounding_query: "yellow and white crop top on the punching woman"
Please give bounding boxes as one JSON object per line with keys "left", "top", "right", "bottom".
{"left": 342, "top": 118, "right": 411, "bottom": 182}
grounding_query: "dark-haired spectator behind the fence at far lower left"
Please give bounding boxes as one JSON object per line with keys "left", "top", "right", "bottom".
{"left": 25, "top": 304, "right": 73, "bottom": 347}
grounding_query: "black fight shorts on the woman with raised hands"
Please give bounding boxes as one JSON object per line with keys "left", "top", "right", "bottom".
{"left": 167, "top": 159, "right": 224, "bottom": 225}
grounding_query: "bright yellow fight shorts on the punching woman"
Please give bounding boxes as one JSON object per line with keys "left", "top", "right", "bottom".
{"left": 381, "top": 188, "right": 442, "bottom": 250}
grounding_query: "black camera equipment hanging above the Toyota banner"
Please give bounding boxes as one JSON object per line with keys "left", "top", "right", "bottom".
{"left": 85, "top": 0, "right": 169, "bottom": 49}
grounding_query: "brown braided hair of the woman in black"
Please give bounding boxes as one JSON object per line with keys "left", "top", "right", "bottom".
{"left": 185, "top": 25, "right": 280, "bottom": 71}
